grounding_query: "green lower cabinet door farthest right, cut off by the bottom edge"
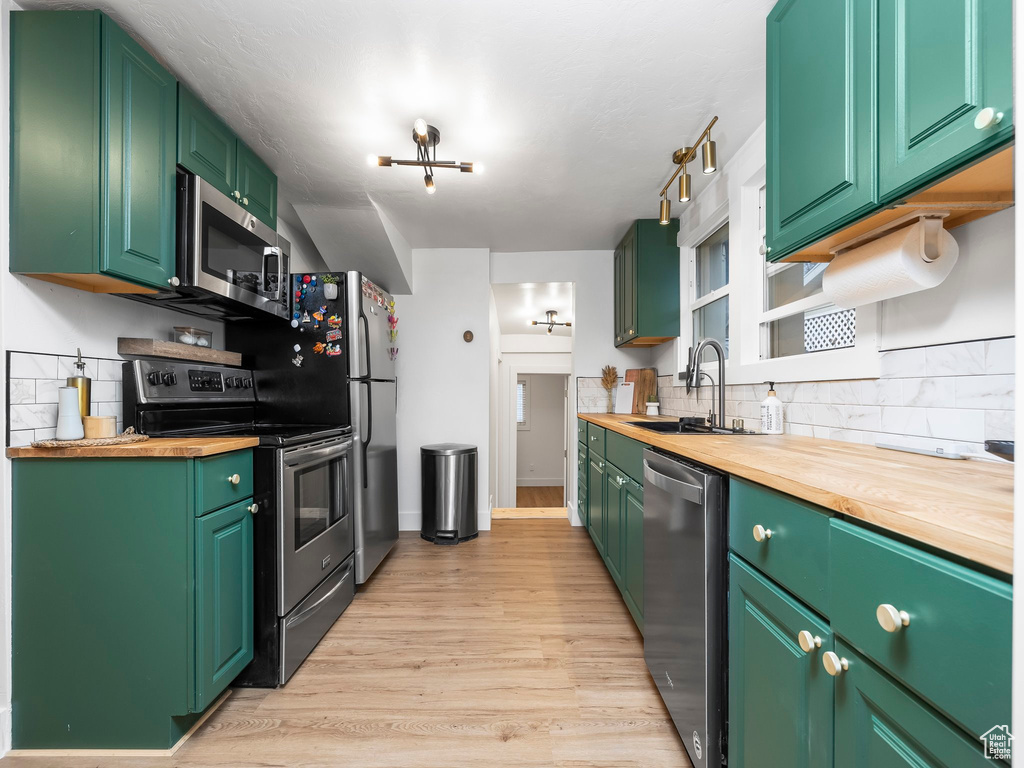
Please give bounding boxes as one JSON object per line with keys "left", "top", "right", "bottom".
{"left": 835, "top": 641, "right": 1005, "bottom": 768}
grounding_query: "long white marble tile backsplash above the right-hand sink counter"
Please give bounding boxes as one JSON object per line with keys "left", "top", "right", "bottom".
{"left": 577, "top": 338, "right": 1015, "bottom": 451}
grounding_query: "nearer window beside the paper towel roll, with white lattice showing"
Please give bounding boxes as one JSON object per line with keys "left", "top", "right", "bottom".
{"left": 758, "top": 186, "right": 857, "bottom": 360}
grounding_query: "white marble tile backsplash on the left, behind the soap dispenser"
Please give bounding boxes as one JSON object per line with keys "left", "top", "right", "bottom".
{"left": 7, "top": 352, "right": 124, "bottom": 446}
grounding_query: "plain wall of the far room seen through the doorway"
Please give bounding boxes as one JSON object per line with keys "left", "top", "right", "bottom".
{"left": 515, "top": 374, "right": 566, "bottom": 485}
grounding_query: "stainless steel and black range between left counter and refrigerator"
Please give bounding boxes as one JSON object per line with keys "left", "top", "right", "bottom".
{"left": 123, "top": 360, "right": 355, "bottom": 687}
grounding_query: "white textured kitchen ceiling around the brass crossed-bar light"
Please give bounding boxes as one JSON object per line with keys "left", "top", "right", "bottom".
{"left": 19, "top": 0, "right": 774, "bottom": 252}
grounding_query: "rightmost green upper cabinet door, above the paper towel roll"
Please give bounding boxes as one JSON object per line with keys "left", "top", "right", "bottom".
{"left": 879, "top": 0, "right": 1014, "bottom": 203}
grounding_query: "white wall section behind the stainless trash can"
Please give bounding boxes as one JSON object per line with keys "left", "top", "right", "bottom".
{"left": 396, "top": 248, "right": 490, "bottom": 530}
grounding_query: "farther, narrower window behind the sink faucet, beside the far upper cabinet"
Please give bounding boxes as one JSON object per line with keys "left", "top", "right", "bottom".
{"left": 690, "top": 222, "right": 729, "bottom": 362}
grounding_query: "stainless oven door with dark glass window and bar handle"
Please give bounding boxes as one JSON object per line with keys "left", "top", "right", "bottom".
{"left": 278, "top": 437, "right": 353, "bottom": 616}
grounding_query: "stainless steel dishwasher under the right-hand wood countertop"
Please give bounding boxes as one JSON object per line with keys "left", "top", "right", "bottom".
{"left": 643, "top": 451, "right": 727, "bottom": 768}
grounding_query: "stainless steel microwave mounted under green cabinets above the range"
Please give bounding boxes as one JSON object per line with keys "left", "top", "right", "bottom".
{"left": 130, "top": 167, "right": 291, "bottom": 319}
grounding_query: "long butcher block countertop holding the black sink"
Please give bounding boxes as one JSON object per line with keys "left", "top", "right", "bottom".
{"left": 579, "top": 414, "right": 1014, "bottom": 573}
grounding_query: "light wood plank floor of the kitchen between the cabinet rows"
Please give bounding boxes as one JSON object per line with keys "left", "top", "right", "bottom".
{"left": 0, "top": 520, "right": 690, "bottom": 768}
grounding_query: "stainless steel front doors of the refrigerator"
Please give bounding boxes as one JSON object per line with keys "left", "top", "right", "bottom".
{"left": 345, "top": 271, "right": 398, "bottom": 584}
